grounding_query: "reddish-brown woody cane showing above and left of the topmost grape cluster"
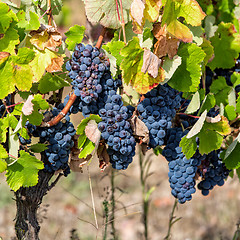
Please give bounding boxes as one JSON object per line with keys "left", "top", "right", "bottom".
{"left": 41, "top": 26, "right": 107, "bottom": 127}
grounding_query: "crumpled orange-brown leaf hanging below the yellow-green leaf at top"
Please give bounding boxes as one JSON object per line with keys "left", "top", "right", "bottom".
{"left": 153, "top": 23, "right": 180, "bottom": 59}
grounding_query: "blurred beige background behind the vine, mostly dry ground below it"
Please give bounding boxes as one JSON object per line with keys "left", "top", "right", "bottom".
{"left": 0, "top": 0, "right": 240, "bottom": 240}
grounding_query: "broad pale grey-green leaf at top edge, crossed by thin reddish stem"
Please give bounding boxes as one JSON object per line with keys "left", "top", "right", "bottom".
{"left": 84, "top": 0, "right": 132, "bottom": 29}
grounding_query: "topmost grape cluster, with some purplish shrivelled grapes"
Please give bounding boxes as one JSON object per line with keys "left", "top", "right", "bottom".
{"left": 66, "top": 43, "right": 109, "bottom": 104}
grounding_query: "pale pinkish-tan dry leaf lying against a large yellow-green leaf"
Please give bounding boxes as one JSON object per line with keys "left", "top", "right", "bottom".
{"left": 141, "top": 49, "right": 161, "bottom": 78}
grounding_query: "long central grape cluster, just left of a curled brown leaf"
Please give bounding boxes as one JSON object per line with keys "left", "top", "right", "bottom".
{"left": 98, "top": 82, "right": 136, "bottom": 170}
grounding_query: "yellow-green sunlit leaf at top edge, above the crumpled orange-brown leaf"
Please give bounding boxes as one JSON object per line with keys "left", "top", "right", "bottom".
{"left": 162, "top": 0, "right": 206, "bottom": 42}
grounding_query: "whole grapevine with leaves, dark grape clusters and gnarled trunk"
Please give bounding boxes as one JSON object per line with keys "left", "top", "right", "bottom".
{"left": 0, "top": 0, "right": 240, "bottom": 239}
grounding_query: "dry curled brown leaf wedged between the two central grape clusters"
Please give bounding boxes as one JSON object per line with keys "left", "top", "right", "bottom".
{"left": 130, "top": 115, "right": 149, "bottom": 144}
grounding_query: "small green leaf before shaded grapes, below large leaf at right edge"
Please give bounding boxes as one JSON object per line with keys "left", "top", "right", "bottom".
{"left": 210, "top": 76, "right": 231, "bottom": 106}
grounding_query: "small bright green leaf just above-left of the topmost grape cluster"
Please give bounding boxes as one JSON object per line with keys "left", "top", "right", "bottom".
{"left": 65, "top": 25, "right": 86, "bottom": 51}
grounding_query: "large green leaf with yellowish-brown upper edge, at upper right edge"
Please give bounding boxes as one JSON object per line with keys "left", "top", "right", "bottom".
{"left": 208, "top": 22, "right": 240, "bottom": 70}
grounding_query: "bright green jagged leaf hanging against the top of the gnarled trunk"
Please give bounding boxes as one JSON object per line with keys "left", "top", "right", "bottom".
{"left": 6, "top": 150, "right": 44, "bottom": 191}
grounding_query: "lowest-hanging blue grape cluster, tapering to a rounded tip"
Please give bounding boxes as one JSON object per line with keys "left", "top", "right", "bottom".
{"left": 162, "top": 128, "right": 203, "bottom": 203}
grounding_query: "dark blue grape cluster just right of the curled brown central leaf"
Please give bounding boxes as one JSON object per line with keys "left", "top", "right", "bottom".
{"left": 137, "top": 84, "right": 181, "bottom": 148}
